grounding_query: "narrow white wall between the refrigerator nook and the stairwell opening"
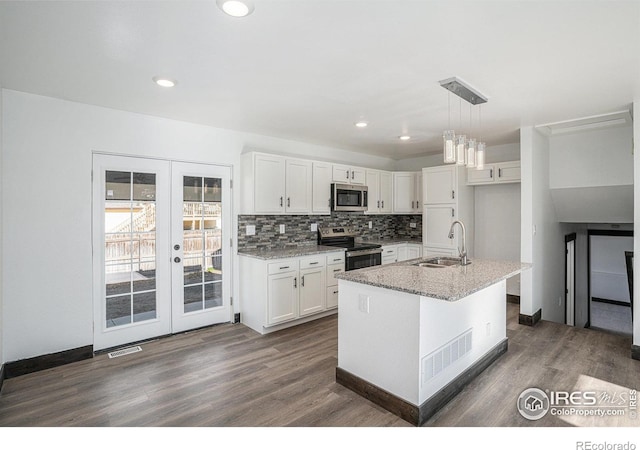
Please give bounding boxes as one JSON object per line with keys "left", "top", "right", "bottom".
{"left": 520, "top": 127, "right": 564, "bottom": 322}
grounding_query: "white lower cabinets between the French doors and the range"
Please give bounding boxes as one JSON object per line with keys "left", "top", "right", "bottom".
{"left": 239, "top": 252, "right": 344, "bottom": 334}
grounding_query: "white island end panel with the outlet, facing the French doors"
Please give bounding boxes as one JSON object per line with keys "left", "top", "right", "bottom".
{"left": 338, "top": 280, "right": 420, "bottom": 406}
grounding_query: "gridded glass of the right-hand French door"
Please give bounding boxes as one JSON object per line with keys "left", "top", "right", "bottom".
{"left": 182, "top": 176, "right": 222, "bottom": 312}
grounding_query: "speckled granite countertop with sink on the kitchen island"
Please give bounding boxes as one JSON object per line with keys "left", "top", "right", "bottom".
{"left": 336, "top": 258, "right": 531, "bottom": 302}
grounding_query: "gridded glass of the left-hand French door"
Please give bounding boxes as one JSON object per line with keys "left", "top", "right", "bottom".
{"left": 104, "top": 171, "right": 156, "bottom": 327}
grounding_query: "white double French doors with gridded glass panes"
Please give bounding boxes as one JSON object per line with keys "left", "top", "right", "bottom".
{"left": 93, "top": 154, "right": 231, "bottom": 350}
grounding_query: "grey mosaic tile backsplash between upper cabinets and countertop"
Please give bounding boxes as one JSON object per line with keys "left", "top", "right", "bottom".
{"left": 238, "top": 212, "right": 422, "bottom": 249}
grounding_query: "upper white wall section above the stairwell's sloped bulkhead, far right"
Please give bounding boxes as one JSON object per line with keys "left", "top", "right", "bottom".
{"left": 549, "top": 126, "right": 633, "bottom": 189}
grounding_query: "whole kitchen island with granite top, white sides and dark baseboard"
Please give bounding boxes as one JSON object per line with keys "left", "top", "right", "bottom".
{"left": 336, "top": 259, "right": 530, "bottom": 425}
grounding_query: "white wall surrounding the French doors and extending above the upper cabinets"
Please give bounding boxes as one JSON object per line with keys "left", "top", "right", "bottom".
{"left": 2, "top": 90, "right": 393, "bottom": 361}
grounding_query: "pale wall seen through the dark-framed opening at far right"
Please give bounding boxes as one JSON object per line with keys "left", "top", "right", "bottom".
{"left": 591, "top": 235, "right": 633, "bottom": 303}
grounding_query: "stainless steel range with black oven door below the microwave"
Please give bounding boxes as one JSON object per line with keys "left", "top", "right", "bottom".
{"left": 318, "top": 227, "right": 382, "bottom": 270}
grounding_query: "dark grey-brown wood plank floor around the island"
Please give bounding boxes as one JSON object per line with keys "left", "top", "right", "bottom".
{"left": 0, "top": 304, "right": 640, "bottom": 427}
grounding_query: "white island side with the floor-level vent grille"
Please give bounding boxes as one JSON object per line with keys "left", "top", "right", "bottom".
{"left": 419, "top": 280, "right": 507, "bottom": 404}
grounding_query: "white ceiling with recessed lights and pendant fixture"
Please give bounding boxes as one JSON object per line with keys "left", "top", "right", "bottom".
{"left": 0, "top": 0, "right": 640, "bottom": 159}
